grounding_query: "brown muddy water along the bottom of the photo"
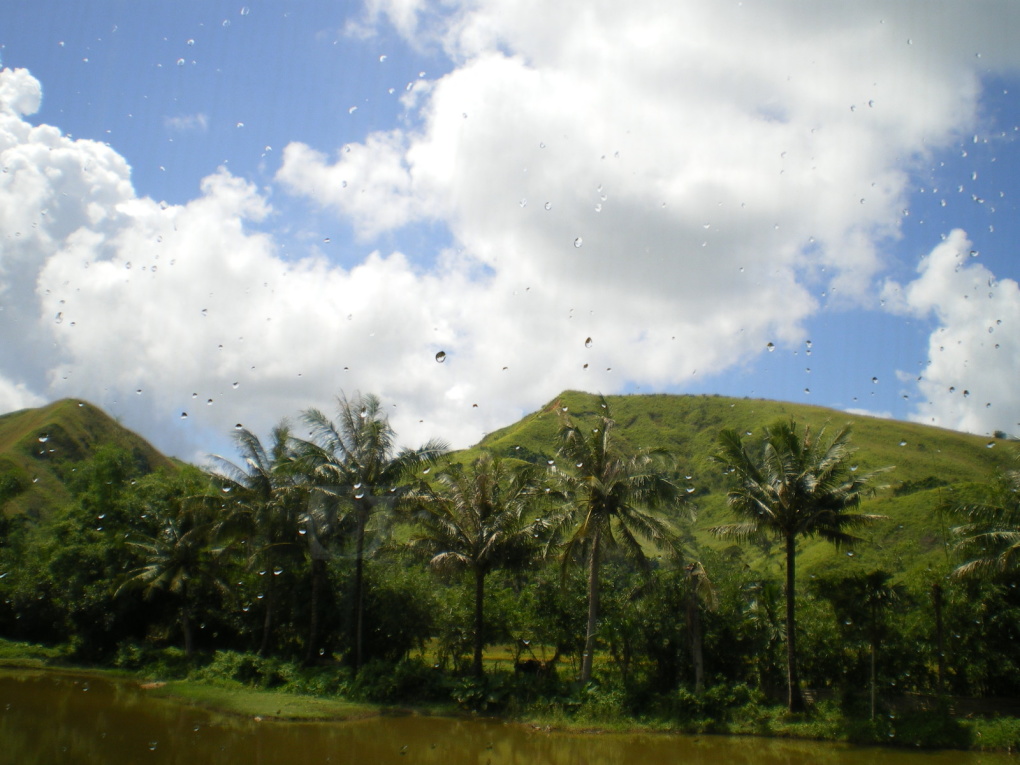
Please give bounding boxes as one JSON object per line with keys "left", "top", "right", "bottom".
{"left": 0, "top": 670, "right": 1014, "bottom": 765}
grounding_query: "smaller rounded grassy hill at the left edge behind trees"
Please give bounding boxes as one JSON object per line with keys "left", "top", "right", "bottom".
{"left": 0, "top": 399, "right": 174, "bottom": 514}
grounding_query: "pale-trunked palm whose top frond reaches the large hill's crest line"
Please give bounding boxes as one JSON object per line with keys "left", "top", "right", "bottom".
{"left": 553, "top": 398, "right": 683, "bottom": 682}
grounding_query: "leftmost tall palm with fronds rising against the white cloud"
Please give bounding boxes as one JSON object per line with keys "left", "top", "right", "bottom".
{"left": 212, "top": 421, "right": 306, "bottom": 656}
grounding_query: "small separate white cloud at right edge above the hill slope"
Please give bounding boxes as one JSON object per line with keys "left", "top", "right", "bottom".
{"left": 884, "top": 230, "right": 1020, "bottom": 435}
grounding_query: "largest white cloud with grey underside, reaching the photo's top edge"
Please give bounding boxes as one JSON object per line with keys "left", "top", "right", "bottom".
{"left": 277, "top": 0, "right": 1016, "bottom": 436}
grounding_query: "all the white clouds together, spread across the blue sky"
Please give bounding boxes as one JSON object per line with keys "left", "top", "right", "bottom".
{"left": 0, "top": 0, "right": 1020, "bottom": 465}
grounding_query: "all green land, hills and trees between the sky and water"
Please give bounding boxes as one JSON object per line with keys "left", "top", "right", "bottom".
{"left": 0, "top": 393, "right": 1020, "bottom": 746}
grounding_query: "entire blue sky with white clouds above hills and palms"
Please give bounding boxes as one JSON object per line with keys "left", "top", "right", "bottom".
{"left": 0, "top": 0, "right": 1020, "bottom": 462}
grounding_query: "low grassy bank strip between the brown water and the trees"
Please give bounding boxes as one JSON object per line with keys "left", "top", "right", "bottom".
{"left": 0, "top": 641, "right": 1020, "bottom": 753}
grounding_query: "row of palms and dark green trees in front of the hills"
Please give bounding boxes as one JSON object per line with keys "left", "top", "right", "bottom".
{"left": 0, "top": 395, "right": 1020, "bottom": 717}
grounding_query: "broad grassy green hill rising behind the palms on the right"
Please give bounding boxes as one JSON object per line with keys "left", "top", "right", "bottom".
{"left": 467, "top": 391, "right": 1017, "bottom": 571}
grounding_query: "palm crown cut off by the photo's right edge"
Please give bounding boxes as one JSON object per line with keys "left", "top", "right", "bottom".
{"left": 953, "top": 452, "right": 1020, "bottom": 577}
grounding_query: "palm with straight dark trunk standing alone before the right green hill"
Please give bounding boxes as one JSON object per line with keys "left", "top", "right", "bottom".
{"left": 712, "top": 422, "right": 887, "bottom": 712}
